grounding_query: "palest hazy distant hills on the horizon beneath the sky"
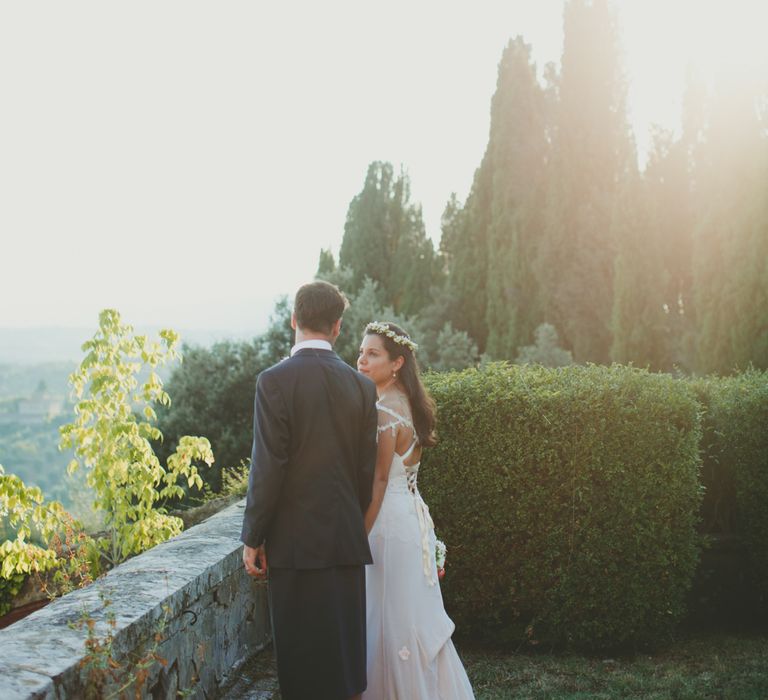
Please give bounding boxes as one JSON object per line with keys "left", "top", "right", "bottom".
{"left": 0, "top": 326, "right": 253, "bottom": 365}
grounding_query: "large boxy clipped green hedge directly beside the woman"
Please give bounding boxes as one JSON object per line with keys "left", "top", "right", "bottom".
{"left": 419, "top": 364, "right": 701, "bottom": 648}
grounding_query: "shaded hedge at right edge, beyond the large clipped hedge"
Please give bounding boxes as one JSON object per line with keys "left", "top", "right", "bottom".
{"left": 689, "top": 370, "right": 768, "bottom": 614}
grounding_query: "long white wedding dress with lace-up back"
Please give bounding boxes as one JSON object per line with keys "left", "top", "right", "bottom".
{"left": 363, "top": 397, "right": 474, "bottom": 700}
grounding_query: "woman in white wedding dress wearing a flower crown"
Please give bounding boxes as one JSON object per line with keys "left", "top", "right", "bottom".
{"left": 357, "top": 322, "right": 474, "bottom": 700}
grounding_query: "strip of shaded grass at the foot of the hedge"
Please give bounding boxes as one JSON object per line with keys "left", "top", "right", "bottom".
{"left": 457, "top": 633, "right": 768, "bottom": 700}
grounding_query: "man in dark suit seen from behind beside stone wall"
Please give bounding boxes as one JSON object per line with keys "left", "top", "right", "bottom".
{"left": 241, "top": 282, "right": 376, "bottom": 700}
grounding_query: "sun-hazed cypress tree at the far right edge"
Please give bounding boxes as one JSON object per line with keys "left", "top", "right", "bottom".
{"left": 694, "top": 80, "right": 768, "bottom": 373}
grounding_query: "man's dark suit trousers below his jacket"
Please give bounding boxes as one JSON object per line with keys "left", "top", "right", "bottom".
{"left": 269, "top": 565, "right": 366, "bottom": 700}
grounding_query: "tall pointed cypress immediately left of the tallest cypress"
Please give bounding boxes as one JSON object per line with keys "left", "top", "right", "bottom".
{"left": 441, "top": 37, "right": 547, "bottom": 359}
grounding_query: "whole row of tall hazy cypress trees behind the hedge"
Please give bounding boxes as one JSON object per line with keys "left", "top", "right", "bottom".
{"left": 318, "top": 0, "right": 768, "bottom": 373}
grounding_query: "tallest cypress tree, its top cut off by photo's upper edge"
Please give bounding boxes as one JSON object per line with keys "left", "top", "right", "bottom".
{"left": 536, "top": 0, "right": 636, "bottom": 362}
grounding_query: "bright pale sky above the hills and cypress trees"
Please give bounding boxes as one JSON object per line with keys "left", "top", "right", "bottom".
{"left": 0, "top": 0, "right": 768, "bottom": 333}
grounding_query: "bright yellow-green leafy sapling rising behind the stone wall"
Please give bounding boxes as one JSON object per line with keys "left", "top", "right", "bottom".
{"left": 61, "top": 309, "right": 213, "bottom": 564}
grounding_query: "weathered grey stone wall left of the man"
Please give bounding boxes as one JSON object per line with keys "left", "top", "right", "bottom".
{"left": 0, "top": 501, "right": 270, "bottom": 700}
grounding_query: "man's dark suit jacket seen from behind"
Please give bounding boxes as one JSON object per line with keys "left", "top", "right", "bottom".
{"left": 241, "top": 348, "right": 377, "bottom": 569}
